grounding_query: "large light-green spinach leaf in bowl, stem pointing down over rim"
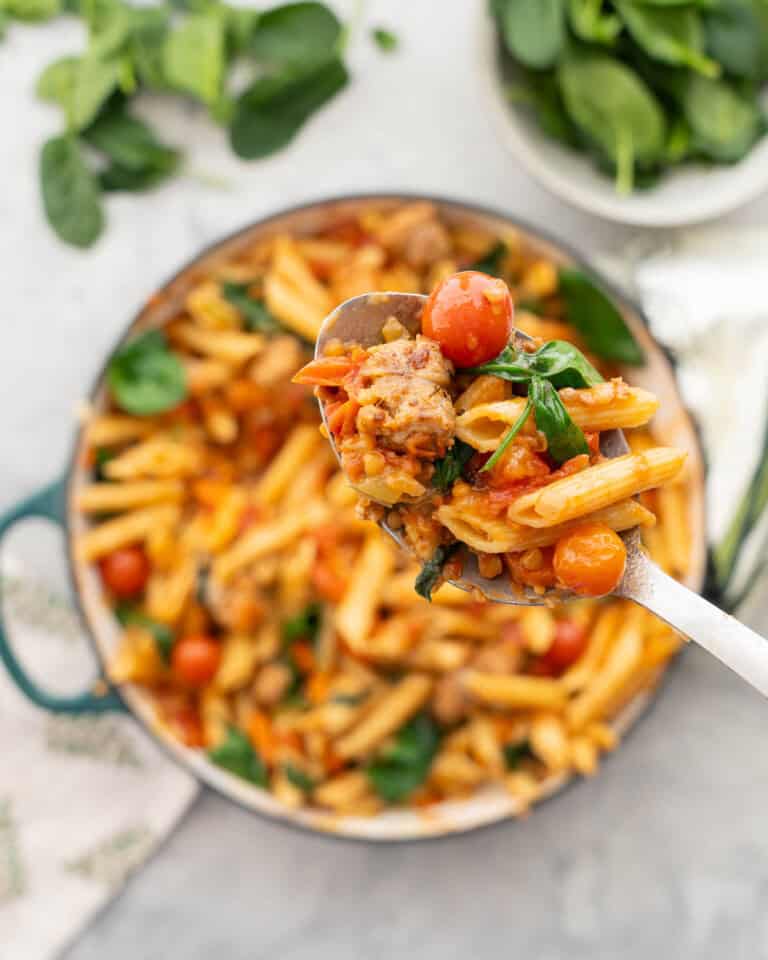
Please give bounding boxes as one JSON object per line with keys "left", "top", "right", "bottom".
{"left": 557, "top": 54, "right": 666, "bottom": 193}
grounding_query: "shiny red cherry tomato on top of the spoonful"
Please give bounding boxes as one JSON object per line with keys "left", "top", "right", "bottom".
{"left": 421, "top": 270, "right": 514, "bottom": 367}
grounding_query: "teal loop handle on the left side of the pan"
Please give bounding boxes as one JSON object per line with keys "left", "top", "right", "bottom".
{"left": 0, "top": 479, "right": 126, "bottom": 713}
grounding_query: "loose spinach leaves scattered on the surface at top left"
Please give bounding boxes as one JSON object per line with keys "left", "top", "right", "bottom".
{"left": 0, "top": 0, "right": 354, "bottom": 247}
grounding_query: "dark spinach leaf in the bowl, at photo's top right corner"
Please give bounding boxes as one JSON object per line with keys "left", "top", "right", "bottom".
{"left": 702, "top": 0, "right": 768, "bottom": 81}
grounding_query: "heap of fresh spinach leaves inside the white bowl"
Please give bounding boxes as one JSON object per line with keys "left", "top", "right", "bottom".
{"left": 491, "top": 0, "right": 768, "bottom": 193}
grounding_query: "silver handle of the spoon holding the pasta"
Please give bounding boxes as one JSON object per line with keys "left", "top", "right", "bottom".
{"left": 620, "top": 554, "right": 768, "bottom": 696}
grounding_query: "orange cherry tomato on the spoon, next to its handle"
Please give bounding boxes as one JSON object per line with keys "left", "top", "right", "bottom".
{"left": 554, "top": 522, "right": 627, "bottom": 597}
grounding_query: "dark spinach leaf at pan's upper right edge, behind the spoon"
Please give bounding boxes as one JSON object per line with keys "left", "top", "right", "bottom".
{"left": 559, "top": 267, "right": 645, "bottom": 366}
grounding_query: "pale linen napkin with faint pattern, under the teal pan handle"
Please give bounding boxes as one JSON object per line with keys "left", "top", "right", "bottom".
{"left": 0, "top": 548, "right": 198, "bottom": 960}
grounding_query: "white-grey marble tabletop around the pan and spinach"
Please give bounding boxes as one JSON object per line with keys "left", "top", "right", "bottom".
{"left": 0, "top": 0, "right": 768, "bottom": 960}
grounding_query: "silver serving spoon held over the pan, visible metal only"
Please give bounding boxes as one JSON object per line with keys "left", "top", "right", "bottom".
{"left": 315, "top": 293, "right": 768, "bottom": 696}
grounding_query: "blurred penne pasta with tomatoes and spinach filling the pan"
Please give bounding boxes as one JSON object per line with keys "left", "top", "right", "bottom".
{"left": 76, "top": 203, "right": 689, "bottom": 816}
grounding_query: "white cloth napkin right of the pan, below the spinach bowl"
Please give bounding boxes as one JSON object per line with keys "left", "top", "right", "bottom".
{"left": 597, "top": 227, "right": 768, "bottom": 592}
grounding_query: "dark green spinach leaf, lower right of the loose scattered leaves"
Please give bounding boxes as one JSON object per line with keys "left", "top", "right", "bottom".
{"left": 230, "top": 59, "right": 348, "bottom": 160}
